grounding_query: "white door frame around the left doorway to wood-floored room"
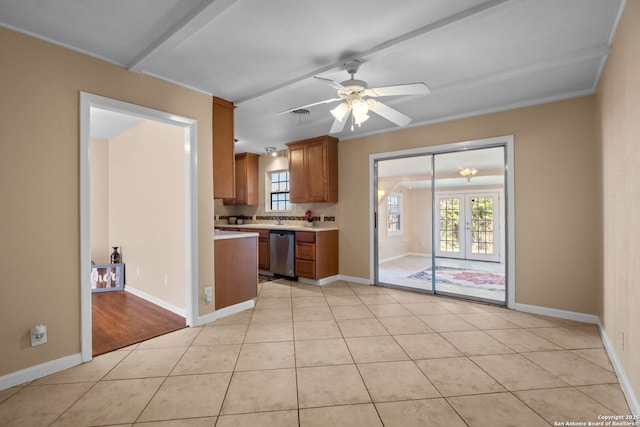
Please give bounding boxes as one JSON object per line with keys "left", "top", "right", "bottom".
{"left": 80, "top": 92, "right": 198, "bottom": 362}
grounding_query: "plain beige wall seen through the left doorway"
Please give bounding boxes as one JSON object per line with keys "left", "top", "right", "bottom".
{"left": 109, "top": 120, "right": 186, "bottom": 310}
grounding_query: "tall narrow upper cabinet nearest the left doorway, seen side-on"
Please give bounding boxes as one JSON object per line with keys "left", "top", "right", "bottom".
{"left": 212, "top": 96, "right": 236, "bottom": 199}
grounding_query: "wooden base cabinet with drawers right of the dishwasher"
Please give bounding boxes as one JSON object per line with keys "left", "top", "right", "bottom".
{"left": 295, "top": 230, "right": 338, "bottom": 280}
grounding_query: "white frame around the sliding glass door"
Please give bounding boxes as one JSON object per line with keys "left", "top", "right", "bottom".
{"left": 369, "top": 135, "right": 516, "bottom": 308}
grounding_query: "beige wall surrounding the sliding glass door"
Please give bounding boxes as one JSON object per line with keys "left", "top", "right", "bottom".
{"left": 338, "top": 96, "right": 599, "bottom": 313}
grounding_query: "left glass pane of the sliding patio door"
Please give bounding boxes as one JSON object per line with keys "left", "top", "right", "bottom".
{"left": 374, "top": 155, "right": 432, "bottom": 291}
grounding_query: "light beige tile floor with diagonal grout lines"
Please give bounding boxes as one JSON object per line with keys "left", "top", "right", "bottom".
{"left": 0, "top": 280, "right": 629, "bottom": 427}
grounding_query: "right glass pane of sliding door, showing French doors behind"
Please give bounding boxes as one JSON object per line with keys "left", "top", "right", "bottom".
{"left": 434, "top": 147, "right": 506, "bottom": 304}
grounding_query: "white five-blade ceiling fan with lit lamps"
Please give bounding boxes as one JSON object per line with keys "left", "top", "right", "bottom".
{"left": 278, "top": 59, "right": 430, "bottom": 133}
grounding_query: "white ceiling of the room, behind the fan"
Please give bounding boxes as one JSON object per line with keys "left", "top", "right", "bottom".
{"left": 0, "top": 0, "right": 624, "bottom": 153}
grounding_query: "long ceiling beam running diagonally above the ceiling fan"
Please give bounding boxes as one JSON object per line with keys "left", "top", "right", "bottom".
{"left": 233, "top": 0, "right": 509, "bottom": 105}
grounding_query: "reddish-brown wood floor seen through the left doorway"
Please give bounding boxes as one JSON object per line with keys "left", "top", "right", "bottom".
{"left": 91, "top": 291, "right": 186, "bottom": 356}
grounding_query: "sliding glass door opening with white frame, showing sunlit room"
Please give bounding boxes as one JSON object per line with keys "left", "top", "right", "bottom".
{"left": 370, "top": 137, "right": 515, "bottom": 306}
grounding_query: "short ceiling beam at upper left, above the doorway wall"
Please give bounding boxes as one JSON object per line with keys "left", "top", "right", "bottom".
{"left": 127, "top": 0, "right": 237, "bottom": 73}
